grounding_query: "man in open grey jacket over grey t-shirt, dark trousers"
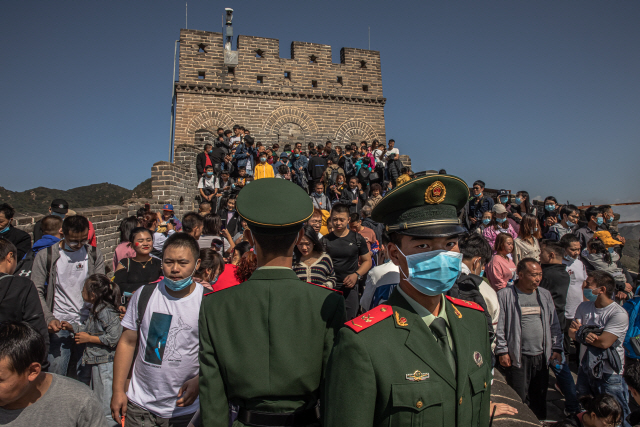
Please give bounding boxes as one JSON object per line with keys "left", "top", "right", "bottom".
{"left": 495, "top": 258, "right": 563, "bottom": 420}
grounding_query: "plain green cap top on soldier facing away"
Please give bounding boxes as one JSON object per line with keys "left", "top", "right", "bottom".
{"left": 236, "top": 178, "right": 313, "bottom": 234}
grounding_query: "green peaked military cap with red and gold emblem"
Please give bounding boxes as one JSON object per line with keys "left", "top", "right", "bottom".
{"left": 371, "top": 174, "right": 469, "bottom": 241}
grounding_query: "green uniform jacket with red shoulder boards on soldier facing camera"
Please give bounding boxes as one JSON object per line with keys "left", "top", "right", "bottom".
{"left": 323, "top": 291, "right": 491, "bottom": 427}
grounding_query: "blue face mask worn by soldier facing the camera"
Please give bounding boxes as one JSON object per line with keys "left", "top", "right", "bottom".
{"left": 400, "top": 250, "right": 462, "bottom": 296}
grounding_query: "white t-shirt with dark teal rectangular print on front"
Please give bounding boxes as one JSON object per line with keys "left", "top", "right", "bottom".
{"left": 122, "top": 281, "right": 204, "bottom": 418}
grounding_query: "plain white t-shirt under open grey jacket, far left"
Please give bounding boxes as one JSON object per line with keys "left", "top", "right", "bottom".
{"left": 53, "top": 246, "right": 91, "bottom": 323}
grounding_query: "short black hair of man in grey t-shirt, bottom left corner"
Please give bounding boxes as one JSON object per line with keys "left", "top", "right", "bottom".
{"left": 0, "top": 321, "right": 47, "bottom": 374}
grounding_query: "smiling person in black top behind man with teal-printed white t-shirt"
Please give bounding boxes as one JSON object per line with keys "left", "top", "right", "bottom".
{"left": 113, "top": 227, "right": 162, "bottom": 305}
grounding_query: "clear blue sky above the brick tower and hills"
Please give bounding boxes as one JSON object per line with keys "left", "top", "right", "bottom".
{"left": 0, "top": 0, "right": 640, "bottom": 219}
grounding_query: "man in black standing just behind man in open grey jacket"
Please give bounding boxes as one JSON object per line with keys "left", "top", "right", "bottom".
{"left": 540, "top": 240, "right": 580, "bottom": 414}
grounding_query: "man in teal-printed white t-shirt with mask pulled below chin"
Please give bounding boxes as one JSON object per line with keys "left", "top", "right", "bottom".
{"left": 111, "top": 233, "right": 205, "bottom": 427}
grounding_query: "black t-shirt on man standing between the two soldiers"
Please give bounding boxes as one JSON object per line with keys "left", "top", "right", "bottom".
{"left": 322, "top": 230, "right": 369, "bottom": 285}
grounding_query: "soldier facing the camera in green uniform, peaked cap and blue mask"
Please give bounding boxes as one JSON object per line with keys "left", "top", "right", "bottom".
{"left": 323, "top": 175, "right": 491, "bottom": 427}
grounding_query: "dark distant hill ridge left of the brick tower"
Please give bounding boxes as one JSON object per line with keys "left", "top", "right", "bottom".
{"left": 0, "top": 178, "right": 151, "bottom": 214}
